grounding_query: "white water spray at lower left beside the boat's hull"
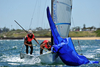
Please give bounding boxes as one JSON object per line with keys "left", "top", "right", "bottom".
{"left": 1, "top": 55, "right": 41, "bottom": 65}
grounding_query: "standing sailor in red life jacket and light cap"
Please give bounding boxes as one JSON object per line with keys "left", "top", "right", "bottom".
{"left": 24, "top": 30, "right": 39, "bottom": 54}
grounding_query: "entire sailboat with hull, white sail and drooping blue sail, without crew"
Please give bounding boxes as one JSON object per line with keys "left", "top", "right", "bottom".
{"left": 20, "top": 0, "right": 99, "bottom": 66}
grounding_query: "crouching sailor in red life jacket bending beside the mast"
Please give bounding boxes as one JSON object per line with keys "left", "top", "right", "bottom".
{"left": 40, "top": 40, "right": 51, "bottom": 54}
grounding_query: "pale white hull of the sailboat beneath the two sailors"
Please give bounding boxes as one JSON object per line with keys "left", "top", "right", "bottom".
{"left": 20, "top": 53, "right": 63, "bottom": 64}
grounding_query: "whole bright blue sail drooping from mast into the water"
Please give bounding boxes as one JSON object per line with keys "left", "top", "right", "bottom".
{"left": 47, "top": 7, "right": 99, "bottom": 66}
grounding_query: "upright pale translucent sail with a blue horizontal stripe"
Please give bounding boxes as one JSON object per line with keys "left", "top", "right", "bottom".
{"left": 53, "top": 0, "right": 72, "bottom": 38}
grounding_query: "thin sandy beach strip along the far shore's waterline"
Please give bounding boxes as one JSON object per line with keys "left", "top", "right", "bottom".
{"left": 0, "top": 37, "right": 100, "bottom": 40}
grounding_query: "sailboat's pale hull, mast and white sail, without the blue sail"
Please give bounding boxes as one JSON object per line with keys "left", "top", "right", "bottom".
{"left": 20, "top": 0, "right": 72, "bottom": 64}
